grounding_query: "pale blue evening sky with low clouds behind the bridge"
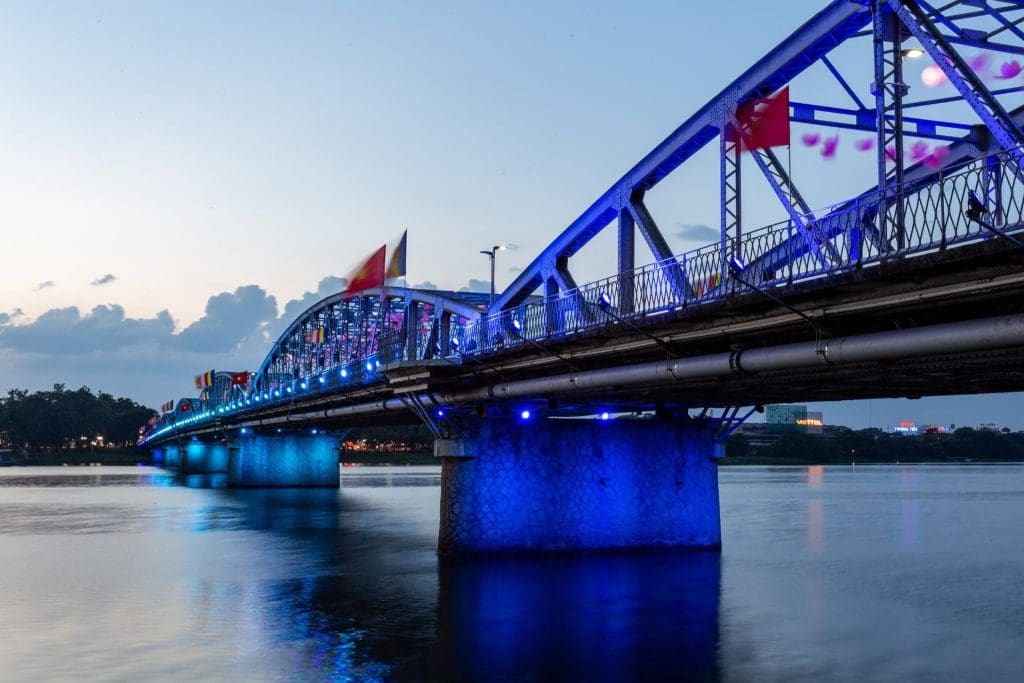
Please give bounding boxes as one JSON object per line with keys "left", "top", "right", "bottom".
{"left": 0, "top": 0, "right": 1024, "bottom": 428}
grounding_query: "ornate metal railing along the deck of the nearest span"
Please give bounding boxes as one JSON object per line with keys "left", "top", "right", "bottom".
{"left": 454, "top": 146, "right": 1024, "bottom": 356}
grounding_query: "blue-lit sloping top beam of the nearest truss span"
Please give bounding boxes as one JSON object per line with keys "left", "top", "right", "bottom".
{"left": 490, "top": 0, "right": 870, "bottom": 311}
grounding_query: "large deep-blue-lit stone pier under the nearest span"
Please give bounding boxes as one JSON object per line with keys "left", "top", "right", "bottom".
{"left": 434, "top": 419, "right": 721, "bottom": 556}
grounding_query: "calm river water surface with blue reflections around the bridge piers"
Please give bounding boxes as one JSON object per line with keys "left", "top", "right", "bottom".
{"left": 0, "top": 465, "right": 1024, "bottom": 682}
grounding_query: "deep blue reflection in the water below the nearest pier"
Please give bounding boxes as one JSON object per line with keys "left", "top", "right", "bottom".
{"left": 439, "top": 553, "right": 721, "bottom": 681}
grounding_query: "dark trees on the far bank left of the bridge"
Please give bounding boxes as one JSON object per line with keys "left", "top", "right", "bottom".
{"left": 0, "top": 384, "right": 157, "bottom": 451}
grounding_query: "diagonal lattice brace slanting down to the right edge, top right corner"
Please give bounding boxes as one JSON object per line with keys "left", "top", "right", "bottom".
{"left": 880, "top": 0, "right": 1024, "bottom": 168}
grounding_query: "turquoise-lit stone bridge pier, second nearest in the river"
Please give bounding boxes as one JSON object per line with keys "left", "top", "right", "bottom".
{"left": 227, "top": 434, "right": 340, "bottom": 487}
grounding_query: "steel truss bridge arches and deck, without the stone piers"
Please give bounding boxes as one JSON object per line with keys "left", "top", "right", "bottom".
{"left": 147, "top": 0, "right": 1024, "bottom": 443}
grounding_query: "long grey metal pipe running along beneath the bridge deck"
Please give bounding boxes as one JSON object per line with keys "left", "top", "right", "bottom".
{"left": 184, "top": 314, "right": 1024, "bottom": 431}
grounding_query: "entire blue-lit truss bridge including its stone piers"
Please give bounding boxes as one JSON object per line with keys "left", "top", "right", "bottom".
{"left": 145, "top": 0, "right": 1024, "bottom": 555}
